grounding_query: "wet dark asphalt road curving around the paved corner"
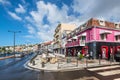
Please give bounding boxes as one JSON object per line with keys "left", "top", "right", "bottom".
{"left": 0, "top": 55, "right": 120, "bottom": 80}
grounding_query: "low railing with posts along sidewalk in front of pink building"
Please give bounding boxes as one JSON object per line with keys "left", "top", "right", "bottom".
{"left": 58, "top": 57, "right": 120, "bottom": 69}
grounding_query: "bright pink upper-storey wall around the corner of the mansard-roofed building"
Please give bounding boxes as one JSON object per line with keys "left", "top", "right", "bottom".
{"left": 85, "top": 27, "right": 120, "bottom": 42}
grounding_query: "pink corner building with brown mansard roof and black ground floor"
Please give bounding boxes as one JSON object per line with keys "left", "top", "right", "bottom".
{"left": 65, "top": 18, "right": 120, "bottom": 59}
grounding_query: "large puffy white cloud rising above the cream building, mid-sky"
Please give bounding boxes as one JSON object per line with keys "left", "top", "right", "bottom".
{"left": 25, "top": 1, "right": 79, "bottom": 41}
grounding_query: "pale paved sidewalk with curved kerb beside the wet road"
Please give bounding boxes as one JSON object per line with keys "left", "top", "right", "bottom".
{"left": 27, "top": 54, "right": 119, "bottom": 71}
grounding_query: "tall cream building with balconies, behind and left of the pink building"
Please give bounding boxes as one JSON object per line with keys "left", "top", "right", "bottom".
{"left": 54, "top": 24, "right": 75, "bottom": 54}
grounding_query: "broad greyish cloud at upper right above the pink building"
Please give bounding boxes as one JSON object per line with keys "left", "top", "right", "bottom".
{"left": 72, "top": 0, "right": 120, "bottom": 21}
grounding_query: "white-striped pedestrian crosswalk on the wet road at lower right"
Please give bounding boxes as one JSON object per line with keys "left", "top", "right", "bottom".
{"left": 87, "top": 65, "right": 120, "bottom": 80}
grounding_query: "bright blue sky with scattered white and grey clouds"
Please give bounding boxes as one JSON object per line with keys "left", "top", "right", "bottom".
{"left": 0, "top": 0, "right": 120, "bottom": 46}
